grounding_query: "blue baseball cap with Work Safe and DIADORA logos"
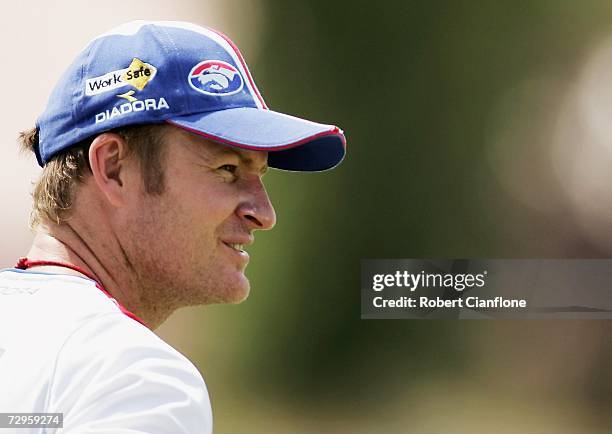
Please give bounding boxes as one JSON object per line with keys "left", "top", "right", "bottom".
{"left": 36, "top": 21, "right": 346, "bottom": 171}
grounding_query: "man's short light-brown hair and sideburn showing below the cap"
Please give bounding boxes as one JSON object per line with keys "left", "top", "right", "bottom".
{"left": 19, "top": 124, "right": 169, "bottom": 228}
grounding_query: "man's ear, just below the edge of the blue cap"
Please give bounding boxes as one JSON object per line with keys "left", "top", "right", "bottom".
{"left": 89, "top": 133, "right": 128, "bottom": 207}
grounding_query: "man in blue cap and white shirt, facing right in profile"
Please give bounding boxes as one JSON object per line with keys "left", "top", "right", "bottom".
{"left": 0, "top": 22, "right": 345, "bottom": 434}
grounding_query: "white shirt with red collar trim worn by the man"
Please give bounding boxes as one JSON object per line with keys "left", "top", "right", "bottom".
{"left": 0, "top": 269, "right": 212, "bottom": 434}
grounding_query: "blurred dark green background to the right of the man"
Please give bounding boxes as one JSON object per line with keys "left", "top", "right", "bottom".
{"left": 154, "top": 0, "right": 612, "bottom": 433}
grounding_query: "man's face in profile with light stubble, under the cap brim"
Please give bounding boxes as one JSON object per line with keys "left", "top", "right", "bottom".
{"left": 123, "top": 127, "right": 276, "bottom": 307}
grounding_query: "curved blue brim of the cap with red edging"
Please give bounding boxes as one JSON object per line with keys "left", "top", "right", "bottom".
{"left": 167, "top": 107, "right": 346, "bottom": 172}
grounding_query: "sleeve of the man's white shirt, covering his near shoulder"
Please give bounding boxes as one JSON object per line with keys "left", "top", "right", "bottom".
{"left": 47, "top": 304, "right": 212, "bottom": 433}
